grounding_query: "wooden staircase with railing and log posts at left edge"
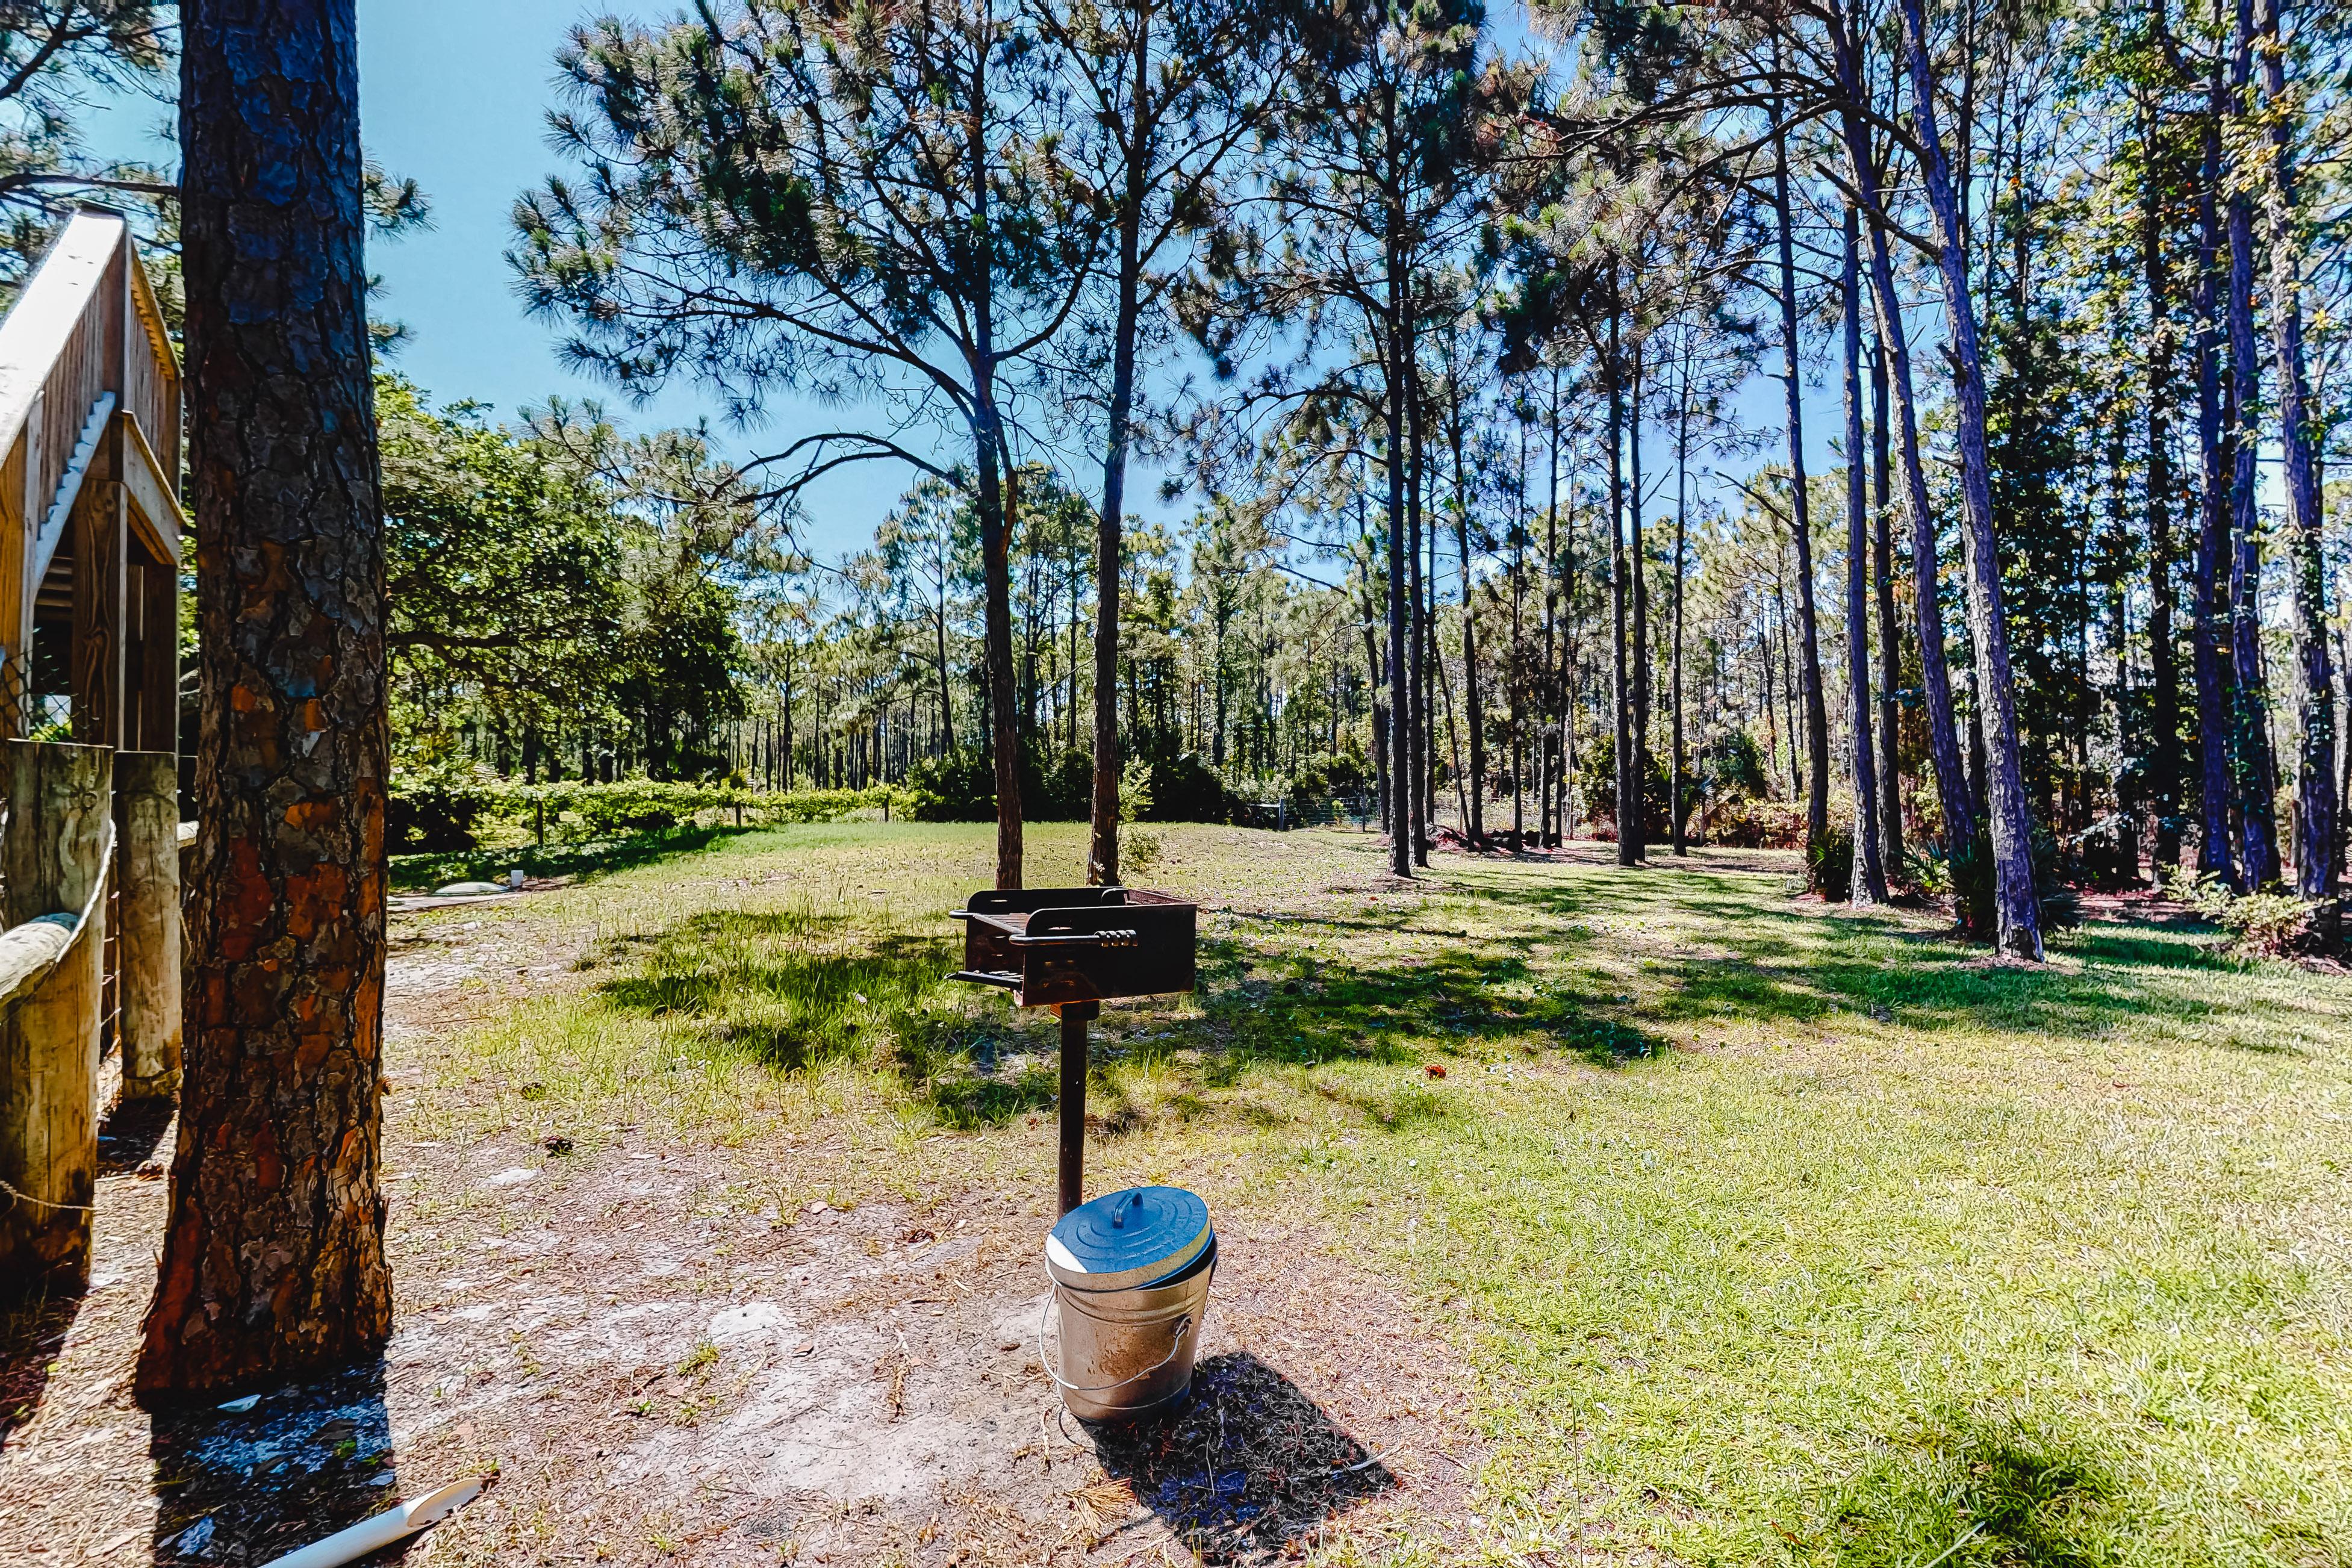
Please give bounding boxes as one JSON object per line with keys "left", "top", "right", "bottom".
{"left": 0, "top": 207, "right": 184, "bottom": 1293}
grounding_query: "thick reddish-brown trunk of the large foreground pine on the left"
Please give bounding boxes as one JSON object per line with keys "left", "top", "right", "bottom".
{"left": 137, "top": 0, "right": 393, "bottom": 1404}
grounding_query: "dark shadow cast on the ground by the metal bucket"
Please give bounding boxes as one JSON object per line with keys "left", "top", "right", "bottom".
{"left": 1094, "top": 1352, "right": 1397, "bottom": 1563}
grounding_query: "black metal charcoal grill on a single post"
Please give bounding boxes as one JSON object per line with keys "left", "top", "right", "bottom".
{"left": 950, "top": 886, "right": 1199, "bottom": 1213}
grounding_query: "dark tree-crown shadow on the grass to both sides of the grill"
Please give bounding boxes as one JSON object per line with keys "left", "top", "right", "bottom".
{"left": 597, "top": 893, "right": 1665, "bottom": 1136}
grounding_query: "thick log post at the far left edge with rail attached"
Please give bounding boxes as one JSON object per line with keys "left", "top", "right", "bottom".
{"left": 0, "top": 741, "right": 113, "bottom": 1290}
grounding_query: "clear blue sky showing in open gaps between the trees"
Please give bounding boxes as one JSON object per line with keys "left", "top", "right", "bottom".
{"left": 92, "top": 0, "right": 1841, "bottom": 571}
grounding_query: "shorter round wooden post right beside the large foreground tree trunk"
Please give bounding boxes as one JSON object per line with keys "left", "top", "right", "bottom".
{"left": 115, "top": 752, "right": 181, "bottom": 1100}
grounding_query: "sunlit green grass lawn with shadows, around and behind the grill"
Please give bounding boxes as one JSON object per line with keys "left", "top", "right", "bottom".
{"left": 409, "top": 823, "right": 2352, "bottom": 1568}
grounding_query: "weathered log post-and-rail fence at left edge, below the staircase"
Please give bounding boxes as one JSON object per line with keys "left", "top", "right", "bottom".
{"left": 0, "top": 741, "right": 181, "bottom": 1290}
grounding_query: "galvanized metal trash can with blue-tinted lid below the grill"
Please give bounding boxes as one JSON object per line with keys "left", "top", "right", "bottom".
{"left": 1039, "top": 1187, "right": 1216, "bottom": 1422}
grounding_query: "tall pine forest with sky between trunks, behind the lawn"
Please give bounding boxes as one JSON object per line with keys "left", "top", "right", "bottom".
{"left": 458, "top": 0, "right": 2352, "bottom": 954}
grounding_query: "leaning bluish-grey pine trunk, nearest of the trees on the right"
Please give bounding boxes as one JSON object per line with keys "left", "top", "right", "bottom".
{"left": 1900, "top": 0, "right": 2041, "bottom": 962}
